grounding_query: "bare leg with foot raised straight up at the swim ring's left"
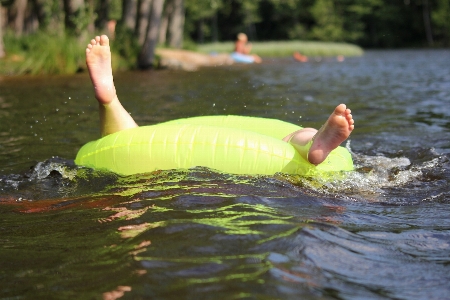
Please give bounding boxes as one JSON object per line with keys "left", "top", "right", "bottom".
{"left": 86, "top": 35, "right": 138, "bottom": 136}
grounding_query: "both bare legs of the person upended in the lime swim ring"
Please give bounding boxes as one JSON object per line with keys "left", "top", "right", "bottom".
{"left": 86, "top": 35, "right": 354, "bottom": 165}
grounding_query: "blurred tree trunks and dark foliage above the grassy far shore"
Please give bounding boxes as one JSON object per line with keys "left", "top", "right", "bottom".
{"left": 0, "top": 0, "right": 450, "bottom": 64}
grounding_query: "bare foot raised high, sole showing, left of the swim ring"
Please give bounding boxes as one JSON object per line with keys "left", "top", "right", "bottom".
{"left": 86, "top": 35, "right": 116, "bottom": 104}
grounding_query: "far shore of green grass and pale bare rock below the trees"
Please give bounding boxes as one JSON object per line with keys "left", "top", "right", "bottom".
{"left": 0, "top": 35, "right": 364, "bottom": 76}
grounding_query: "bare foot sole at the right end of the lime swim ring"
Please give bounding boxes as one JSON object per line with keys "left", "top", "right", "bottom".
{"left": 308, "top": 104, "right": 355, "bottom": 165}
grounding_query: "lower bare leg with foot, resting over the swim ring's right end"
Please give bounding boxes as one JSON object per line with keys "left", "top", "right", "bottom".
{"left": 283, "top": 104, "right": 355, "bottom": 165}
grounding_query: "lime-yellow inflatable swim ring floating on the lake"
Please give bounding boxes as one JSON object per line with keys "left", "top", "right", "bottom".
{"left": 75, "top": 116, "right": 353, "bottom": 176}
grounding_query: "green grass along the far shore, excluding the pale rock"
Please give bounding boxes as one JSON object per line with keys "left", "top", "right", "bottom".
{"left": 0, "top": 33, "right": 363, "bottom": 76}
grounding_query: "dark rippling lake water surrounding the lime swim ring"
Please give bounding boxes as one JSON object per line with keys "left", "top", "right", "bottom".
{"left": 0, "top": 50, "right": 450, "bottom": 299}
